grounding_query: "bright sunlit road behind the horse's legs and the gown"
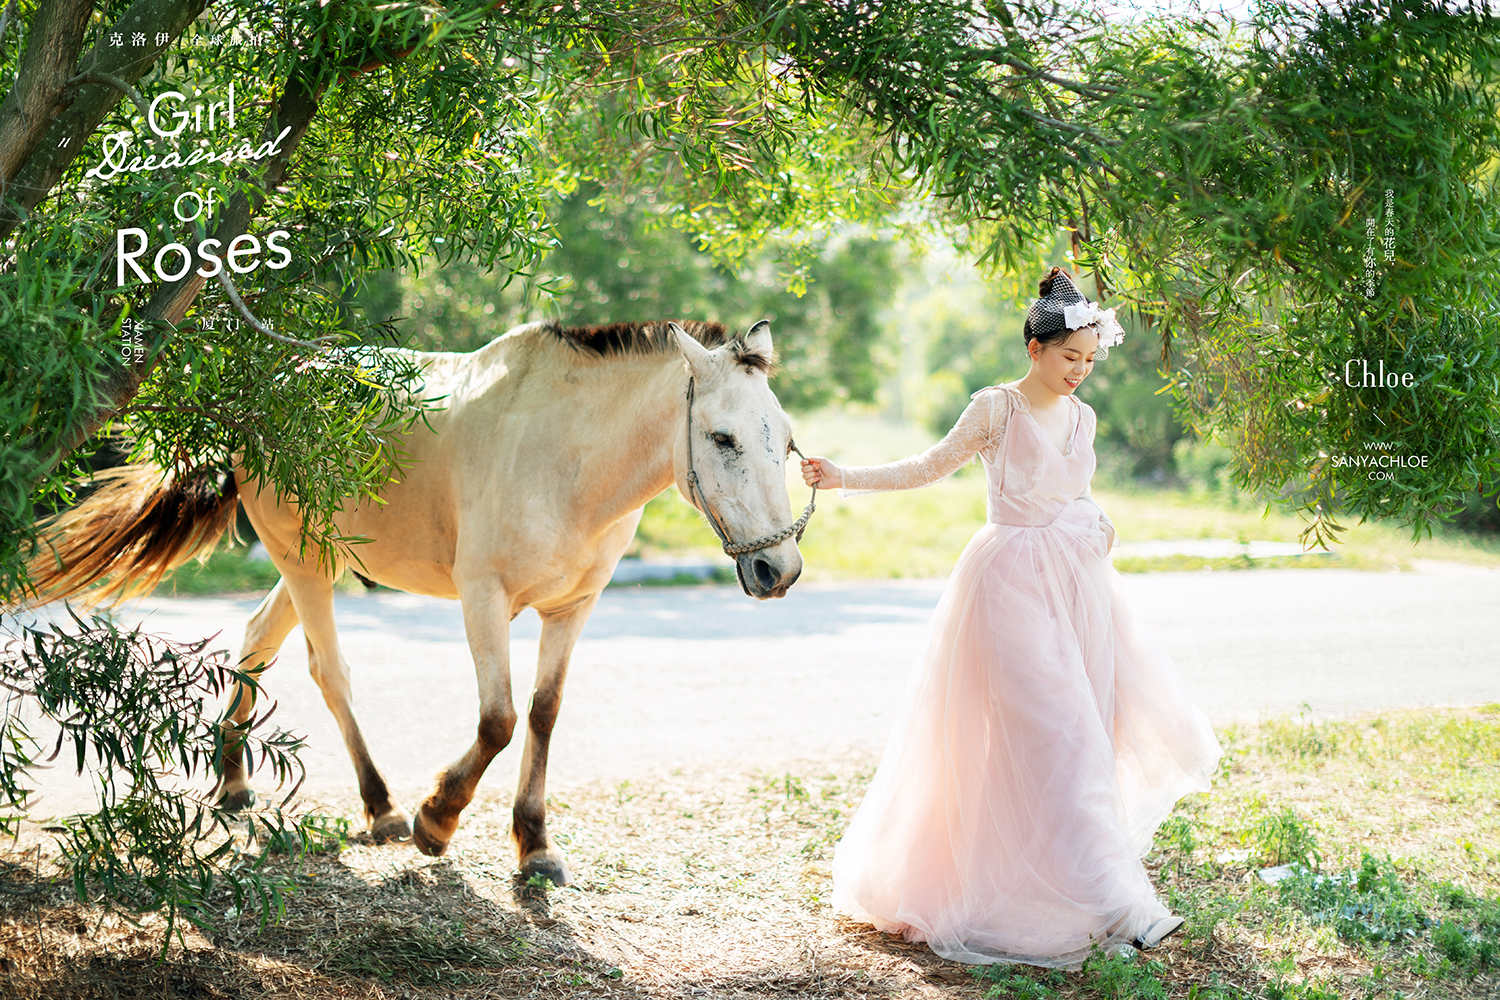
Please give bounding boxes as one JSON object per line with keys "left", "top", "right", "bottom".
{"left": 14, "top": 564, "right": 1500, "bottom": 814}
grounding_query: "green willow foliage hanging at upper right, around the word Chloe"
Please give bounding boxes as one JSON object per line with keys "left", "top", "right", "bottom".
{"left": 579, "top": 0, "right": 1500, "bottom": 544}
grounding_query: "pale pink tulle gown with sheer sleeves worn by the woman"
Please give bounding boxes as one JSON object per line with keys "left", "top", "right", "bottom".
{"left": 833, "top": 387, "right": 1221, "bottom": 969}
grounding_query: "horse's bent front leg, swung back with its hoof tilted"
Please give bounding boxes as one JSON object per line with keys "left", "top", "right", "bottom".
{"left": 413, "top": 576, "right": 516, "bottom": 855}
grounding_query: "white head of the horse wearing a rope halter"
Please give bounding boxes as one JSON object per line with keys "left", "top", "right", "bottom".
{"left": 672, "top": 319, "right": 803, "bottom": 600}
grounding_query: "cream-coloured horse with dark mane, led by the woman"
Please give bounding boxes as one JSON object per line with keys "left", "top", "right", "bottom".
{"left": 20, "top": 321, "right": 812, "bottom": 886}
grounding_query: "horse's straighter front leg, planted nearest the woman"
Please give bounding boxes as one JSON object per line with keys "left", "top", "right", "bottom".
{"left": 510, "top": 594, "right": 599, "bottom": 886}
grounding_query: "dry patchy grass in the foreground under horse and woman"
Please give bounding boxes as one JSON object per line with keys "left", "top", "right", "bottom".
{"left": 0, "top": 705, "right": 1500, "bottom": 1000}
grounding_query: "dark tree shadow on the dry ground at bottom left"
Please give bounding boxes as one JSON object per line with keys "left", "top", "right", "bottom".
{"left": 0, "top": 843, "right": 644, "bottom": 1000}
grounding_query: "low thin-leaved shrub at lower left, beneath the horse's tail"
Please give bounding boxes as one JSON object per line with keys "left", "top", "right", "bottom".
{"left": 0, "top": 607, "right": 306, "bottom": 951}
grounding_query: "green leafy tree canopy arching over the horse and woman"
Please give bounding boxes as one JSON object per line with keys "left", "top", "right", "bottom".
{"left": 0, "top": 0, "right": 1500, "bottom": 591}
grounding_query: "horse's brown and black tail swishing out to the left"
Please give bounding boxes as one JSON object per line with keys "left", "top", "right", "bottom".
{"left": 26, "top": 465, "right": 239, "bottom": 606}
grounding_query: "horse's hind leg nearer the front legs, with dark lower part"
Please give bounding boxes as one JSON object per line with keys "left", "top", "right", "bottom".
{"left": 282, "top": 570, "right": 411, "bottom": 843}
